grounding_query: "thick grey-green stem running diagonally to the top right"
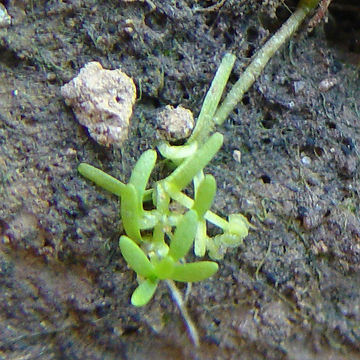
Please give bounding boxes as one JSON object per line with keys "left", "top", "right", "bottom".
{"left": 214, "top": 0, "right": 318, "bottom": 125}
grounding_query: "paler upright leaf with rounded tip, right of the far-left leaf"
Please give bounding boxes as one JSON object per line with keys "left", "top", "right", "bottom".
{"left": 129, "top": 150, "right": 156, "bottom": 207}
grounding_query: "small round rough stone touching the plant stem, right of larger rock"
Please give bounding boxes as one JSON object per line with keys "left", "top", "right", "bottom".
{"left": 157, "top": 105, "right": 194, "bottom": 141}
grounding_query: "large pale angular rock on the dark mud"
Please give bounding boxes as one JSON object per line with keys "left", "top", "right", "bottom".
{"left": 61, "top": 62, "right": 136, "bottom": 146}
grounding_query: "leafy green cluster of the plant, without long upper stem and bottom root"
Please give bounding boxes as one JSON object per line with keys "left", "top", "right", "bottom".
{"left": 78, "top": 133, "right": 249, "bottom": 306}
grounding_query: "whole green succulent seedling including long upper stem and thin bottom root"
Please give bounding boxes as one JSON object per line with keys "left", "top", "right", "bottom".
{"left": 78, "top": 0, "right": 319, "bottom": 345}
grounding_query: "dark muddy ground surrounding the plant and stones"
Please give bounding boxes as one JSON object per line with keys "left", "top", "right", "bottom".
{"left": 0, "top": 0, "right": 360, "bottom": 360}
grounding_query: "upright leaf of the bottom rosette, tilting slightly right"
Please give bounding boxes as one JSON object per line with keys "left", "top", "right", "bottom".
{"left": 169, "top": 210, "right": 198, "bottom": 261}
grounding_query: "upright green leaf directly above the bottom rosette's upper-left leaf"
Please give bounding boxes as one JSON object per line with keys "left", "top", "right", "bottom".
{"left": 120, "top": 184, "right": 142, "bottom": 243}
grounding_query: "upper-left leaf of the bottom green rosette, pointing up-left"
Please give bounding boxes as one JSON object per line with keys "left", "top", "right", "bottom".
{"left": 119, "top": 236, "right": 155, "bottom": 278}
